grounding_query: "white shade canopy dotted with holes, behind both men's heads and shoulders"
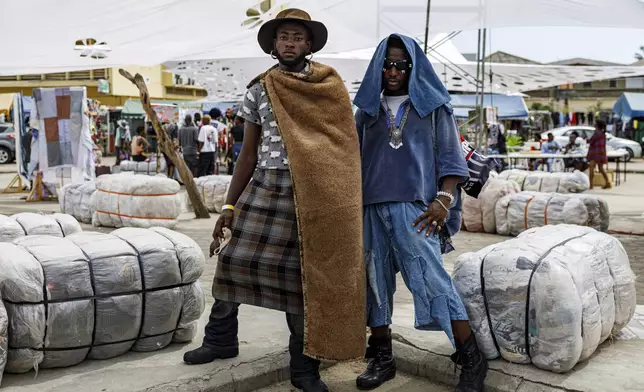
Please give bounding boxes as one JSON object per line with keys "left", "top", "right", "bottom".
{"left": 170, "top": 52, "right": 644, "bottom": 101}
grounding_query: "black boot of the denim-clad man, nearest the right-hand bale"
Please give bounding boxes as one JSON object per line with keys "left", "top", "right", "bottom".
{"left": 452, "top": 334, "right": 488, "bottom": 392}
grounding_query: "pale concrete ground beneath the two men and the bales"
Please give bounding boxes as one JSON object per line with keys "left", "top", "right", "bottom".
{"left": 0, "top": 158, "right": 644, "bottom": 392}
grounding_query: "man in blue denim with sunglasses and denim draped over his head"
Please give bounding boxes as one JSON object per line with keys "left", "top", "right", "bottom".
{"left": 354, "top": 34, "right": 488, "bottom": 392}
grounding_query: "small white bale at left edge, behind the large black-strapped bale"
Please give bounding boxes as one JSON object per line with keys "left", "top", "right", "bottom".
{"left": 0, "top": 212, "right": 83, "bottom": 242}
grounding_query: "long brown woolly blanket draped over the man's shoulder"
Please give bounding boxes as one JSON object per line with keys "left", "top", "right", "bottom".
{"left": 260, "top": 62, "right": 366, "bottom": 361}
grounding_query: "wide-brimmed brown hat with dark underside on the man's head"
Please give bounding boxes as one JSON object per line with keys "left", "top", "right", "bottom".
{"left": 257, "top": 8, "right": 329, "bottom": 54}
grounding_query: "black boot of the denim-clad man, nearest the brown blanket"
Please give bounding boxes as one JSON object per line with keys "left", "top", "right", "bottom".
{"left": 356, "top": 331, "right": 396, "bottom": 390}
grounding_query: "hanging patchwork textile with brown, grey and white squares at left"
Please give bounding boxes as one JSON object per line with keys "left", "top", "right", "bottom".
{"left": 32, "top": 87, "right": 95, "bottom": 178}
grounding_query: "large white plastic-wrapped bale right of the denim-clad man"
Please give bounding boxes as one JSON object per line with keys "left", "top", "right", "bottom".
{"left": 453, "top": 225, "right": 636, "bottom": 373}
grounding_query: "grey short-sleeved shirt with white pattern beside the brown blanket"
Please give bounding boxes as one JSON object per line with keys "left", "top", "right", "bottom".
{"left": 237, "top": 82, "right": 288, "bottom": 170}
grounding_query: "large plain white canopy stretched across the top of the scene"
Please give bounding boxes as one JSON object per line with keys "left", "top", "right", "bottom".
{"left": 5, "top": 0, "right": 644, "bottom": 75}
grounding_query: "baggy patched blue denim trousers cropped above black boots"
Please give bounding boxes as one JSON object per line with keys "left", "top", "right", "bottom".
{"left": 364, "top": 202, "right": 468, "bottom": 344}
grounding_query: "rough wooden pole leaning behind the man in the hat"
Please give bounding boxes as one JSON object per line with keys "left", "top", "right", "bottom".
{"left": 119, "top": 69, "right": 210, "bottom": 219}
